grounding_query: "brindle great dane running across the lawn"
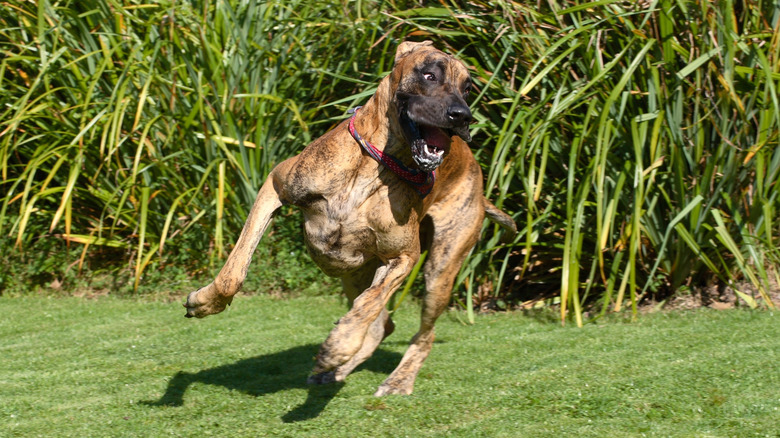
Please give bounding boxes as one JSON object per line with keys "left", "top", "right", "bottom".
{"left": 184, "top": 41, "right": 517, "bottom": 396}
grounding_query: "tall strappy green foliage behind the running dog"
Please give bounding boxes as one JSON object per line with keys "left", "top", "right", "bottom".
{"left": 0, "top": 0, "right": 780, "bottom": 323}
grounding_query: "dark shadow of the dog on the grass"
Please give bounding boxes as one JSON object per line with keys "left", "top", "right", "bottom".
{"left": 142, "top": 344, "right": 401, "bottom": 423}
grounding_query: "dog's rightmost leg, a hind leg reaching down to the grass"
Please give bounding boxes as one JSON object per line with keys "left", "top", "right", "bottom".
{"left": 374, "top": 202, "right": 483, "bottom": 397}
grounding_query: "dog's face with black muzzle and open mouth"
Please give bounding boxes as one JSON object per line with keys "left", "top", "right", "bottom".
{"left": 392, "top": 41, "right": 472, "bottom": 172}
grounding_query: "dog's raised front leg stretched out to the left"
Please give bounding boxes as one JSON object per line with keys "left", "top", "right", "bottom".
{"left": 184, "top": 157, "right": 295, "bottom": 318}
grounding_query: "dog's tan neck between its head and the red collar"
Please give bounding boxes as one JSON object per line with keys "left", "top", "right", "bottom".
{"left": 355, "top": 76, "right": 417, "bottom": 169}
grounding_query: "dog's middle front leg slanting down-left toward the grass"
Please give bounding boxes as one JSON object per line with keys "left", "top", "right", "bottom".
{"left": 309, "top": 254, "right": 419, "bottom": 376}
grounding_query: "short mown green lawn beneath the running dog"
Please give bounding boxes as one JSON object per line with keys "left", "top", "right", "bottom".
{"left": 0, "top": 296, "right": 780, "bottom": 437}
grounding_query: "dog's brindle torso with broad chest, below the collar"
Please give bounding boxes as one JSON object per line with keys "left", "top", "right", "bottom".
{"left": 280, "top": 112, "right": 482, "bottom": 277}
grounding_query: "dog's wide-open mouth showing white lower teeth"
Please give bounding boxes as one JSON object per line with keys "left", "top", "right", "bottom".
{"left": 401, "top": 112, "right": 468, "bottom": 172}
